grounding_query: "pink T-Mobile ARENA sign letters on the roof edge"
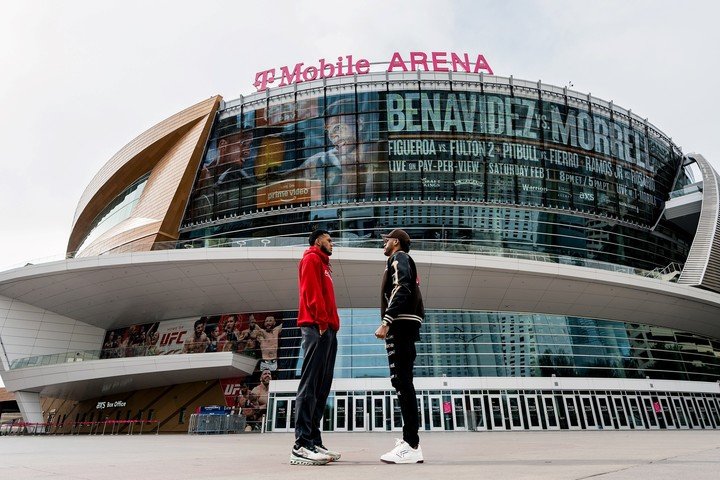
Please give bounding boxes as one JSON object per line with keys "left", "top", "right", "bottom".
{"left": 253, "top": 52, "right": 493, "bottom": 92}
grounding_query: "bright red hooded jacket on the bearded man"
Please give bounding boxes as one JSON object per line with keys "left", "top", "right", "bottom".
{"left": 298, "top": 246, "right": 340, "bottom": 332}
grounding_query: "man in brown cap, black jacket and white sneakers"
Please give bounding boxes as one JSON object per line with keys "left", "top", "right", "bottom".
{"left": 375, "top": 229, "right": 425, "bottom": 463}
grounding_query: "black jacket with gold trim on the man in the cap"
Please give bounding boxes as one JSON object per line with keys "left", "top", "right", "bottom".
{"left": 380, "top": 251, "right": 425, "bottom": 338}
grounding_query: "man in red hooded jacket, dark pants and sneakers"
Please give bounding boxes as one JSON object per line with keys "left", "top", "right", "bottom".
{"left": 290, "top": 229, "right": 340, "bottom": 465}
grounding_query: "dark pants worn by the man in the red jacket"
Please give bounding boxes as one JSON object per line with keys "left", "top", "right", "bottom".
{"left": 295, "top": 326, "right": 337, "bottom": 447}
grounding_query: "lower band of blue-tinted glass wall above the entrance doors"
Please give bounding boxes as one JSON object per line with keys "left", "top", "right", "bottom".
{"left": 270, "top": 309, "right": 720, "bottom": 382}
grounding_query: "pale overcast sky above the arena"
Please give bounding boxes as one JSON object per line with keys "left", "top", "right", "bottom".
{"left": 0, "top": 0, "right": 720, "bottom": 271}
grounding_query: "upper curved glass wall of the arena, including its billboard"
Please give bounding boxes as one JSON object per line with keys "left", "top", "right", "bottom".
{"left": 181, "top": 77, "right": 691, "bottom": 270}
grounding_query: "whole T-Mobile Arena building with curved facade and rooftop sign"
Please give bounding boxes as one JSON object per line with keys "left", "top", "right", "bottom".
{"left": 0, "top": 52, "right": 720, "bottom": 432}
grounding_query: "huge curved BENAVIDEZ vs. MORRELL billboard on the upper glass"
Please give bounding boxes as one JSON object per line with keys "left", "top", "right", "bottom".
{"left": 191, "top": 88, "right": 680, "bottom": 225}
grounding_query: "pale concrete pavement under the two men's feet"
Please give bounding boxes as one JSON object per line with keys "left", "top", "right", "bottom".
{"left": 0, "top": 430, "right": 720, "bottom": 480}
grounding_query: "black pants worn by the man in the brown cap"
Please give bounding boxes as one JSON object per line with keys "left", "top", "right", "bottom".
{"left": 385, "top": 332, "right": 420, "bottom": 448}
